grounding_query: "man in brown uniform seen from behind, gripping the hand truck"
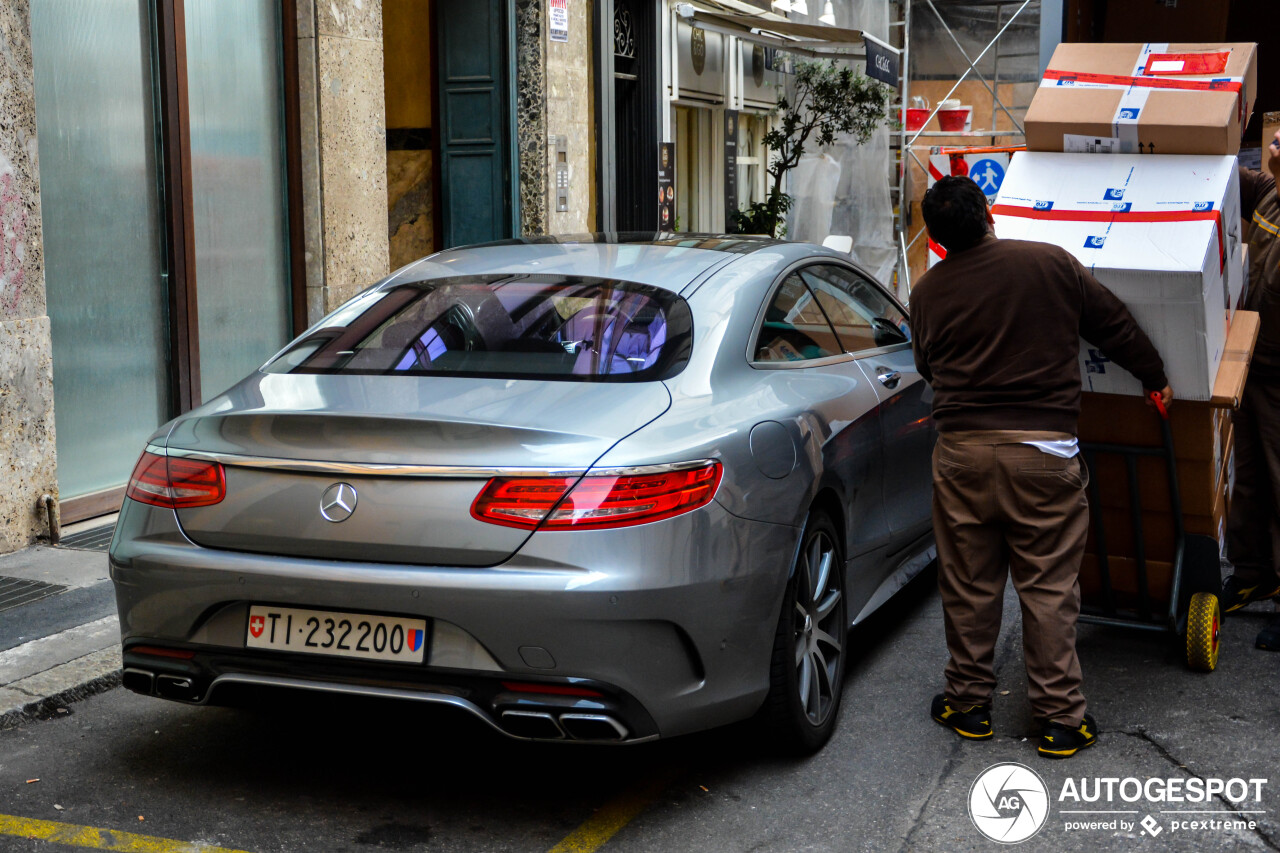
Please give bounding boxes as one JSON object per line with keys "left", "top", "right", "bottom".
{"left": 911, "top": 177, "right": 1172, "bottom": 758}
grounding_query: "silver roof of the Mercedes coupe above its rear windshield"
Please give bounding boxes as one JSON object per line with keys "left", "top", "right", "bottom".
{"left": 387, "top": 232, "right": 786, "bottom": 292}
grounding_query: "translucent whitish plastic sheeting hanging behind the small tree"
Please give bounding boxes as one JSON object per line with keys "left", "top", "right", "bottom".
{"left": 787, "top": 0, "right": 897, "bottom": 284}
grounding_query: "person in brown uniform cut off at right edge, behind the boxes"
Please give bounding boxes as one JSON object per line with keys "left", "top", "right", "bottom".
{"left": 1222, "top": 134, "right": 1280, "bottom": 651}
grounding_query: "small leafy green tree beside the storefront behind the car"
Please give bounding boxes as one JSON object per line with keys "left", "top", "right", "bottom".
{"left": 730, "top": 60, "right": 891, "bottom": 237}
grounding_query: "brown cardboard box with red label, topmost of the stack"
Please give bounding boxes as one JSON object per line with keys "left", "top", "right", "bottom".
{"left": 1024, "top": 42, "right": 1257, "bottom": 155}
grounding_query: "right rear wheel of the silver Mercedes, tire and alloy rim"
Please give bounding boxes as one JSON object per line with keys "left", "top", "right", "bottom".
{"left": 760, "top": 511, "right": 849, "bottom": 754}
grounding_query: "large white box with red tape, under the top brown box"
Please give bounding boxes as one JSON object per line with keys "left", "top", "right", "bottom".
{"left": 992, "top": 151, "right": 1244, "bottom": 401}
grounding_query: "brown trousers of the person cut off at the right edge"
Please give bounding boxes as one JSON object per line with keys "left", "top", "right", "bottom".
{"left": 1226, "top": 377, "right": 1280, "bottom": 585}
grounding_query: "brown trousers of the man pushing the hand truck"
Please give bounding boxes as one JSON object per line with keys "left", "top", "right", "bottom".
{"left": 933, "top": 430, "right": 1089, "bottom": 726}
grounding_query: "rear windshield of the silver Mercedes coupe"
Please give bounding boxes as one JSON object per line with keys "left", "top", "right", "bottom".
{"left": 264, "top": 275, "right": 692, "bottom": 382}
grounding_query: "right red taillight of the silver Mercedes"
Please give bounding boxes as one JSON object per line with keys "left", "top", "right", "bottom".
{"left": 471, "top": 462, "right": 721, "bottom": 530}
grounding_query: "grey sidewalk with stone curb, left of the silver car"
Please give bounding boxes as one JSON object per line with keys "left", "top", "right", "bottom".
{"left": 0, "top": 546, "right": 120, "bottom": 729}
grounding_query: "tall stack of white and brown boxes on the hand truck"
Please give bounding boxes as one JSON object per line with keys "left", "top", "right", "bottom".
{"left": 992, "top": 44, "right": 1257, "bottom": 606}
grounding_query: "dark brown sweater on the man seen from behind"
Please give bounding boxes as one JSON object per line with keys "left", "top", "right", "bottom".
{"left": 911, "top": 234, "right": 1169, "bottom": 435}
